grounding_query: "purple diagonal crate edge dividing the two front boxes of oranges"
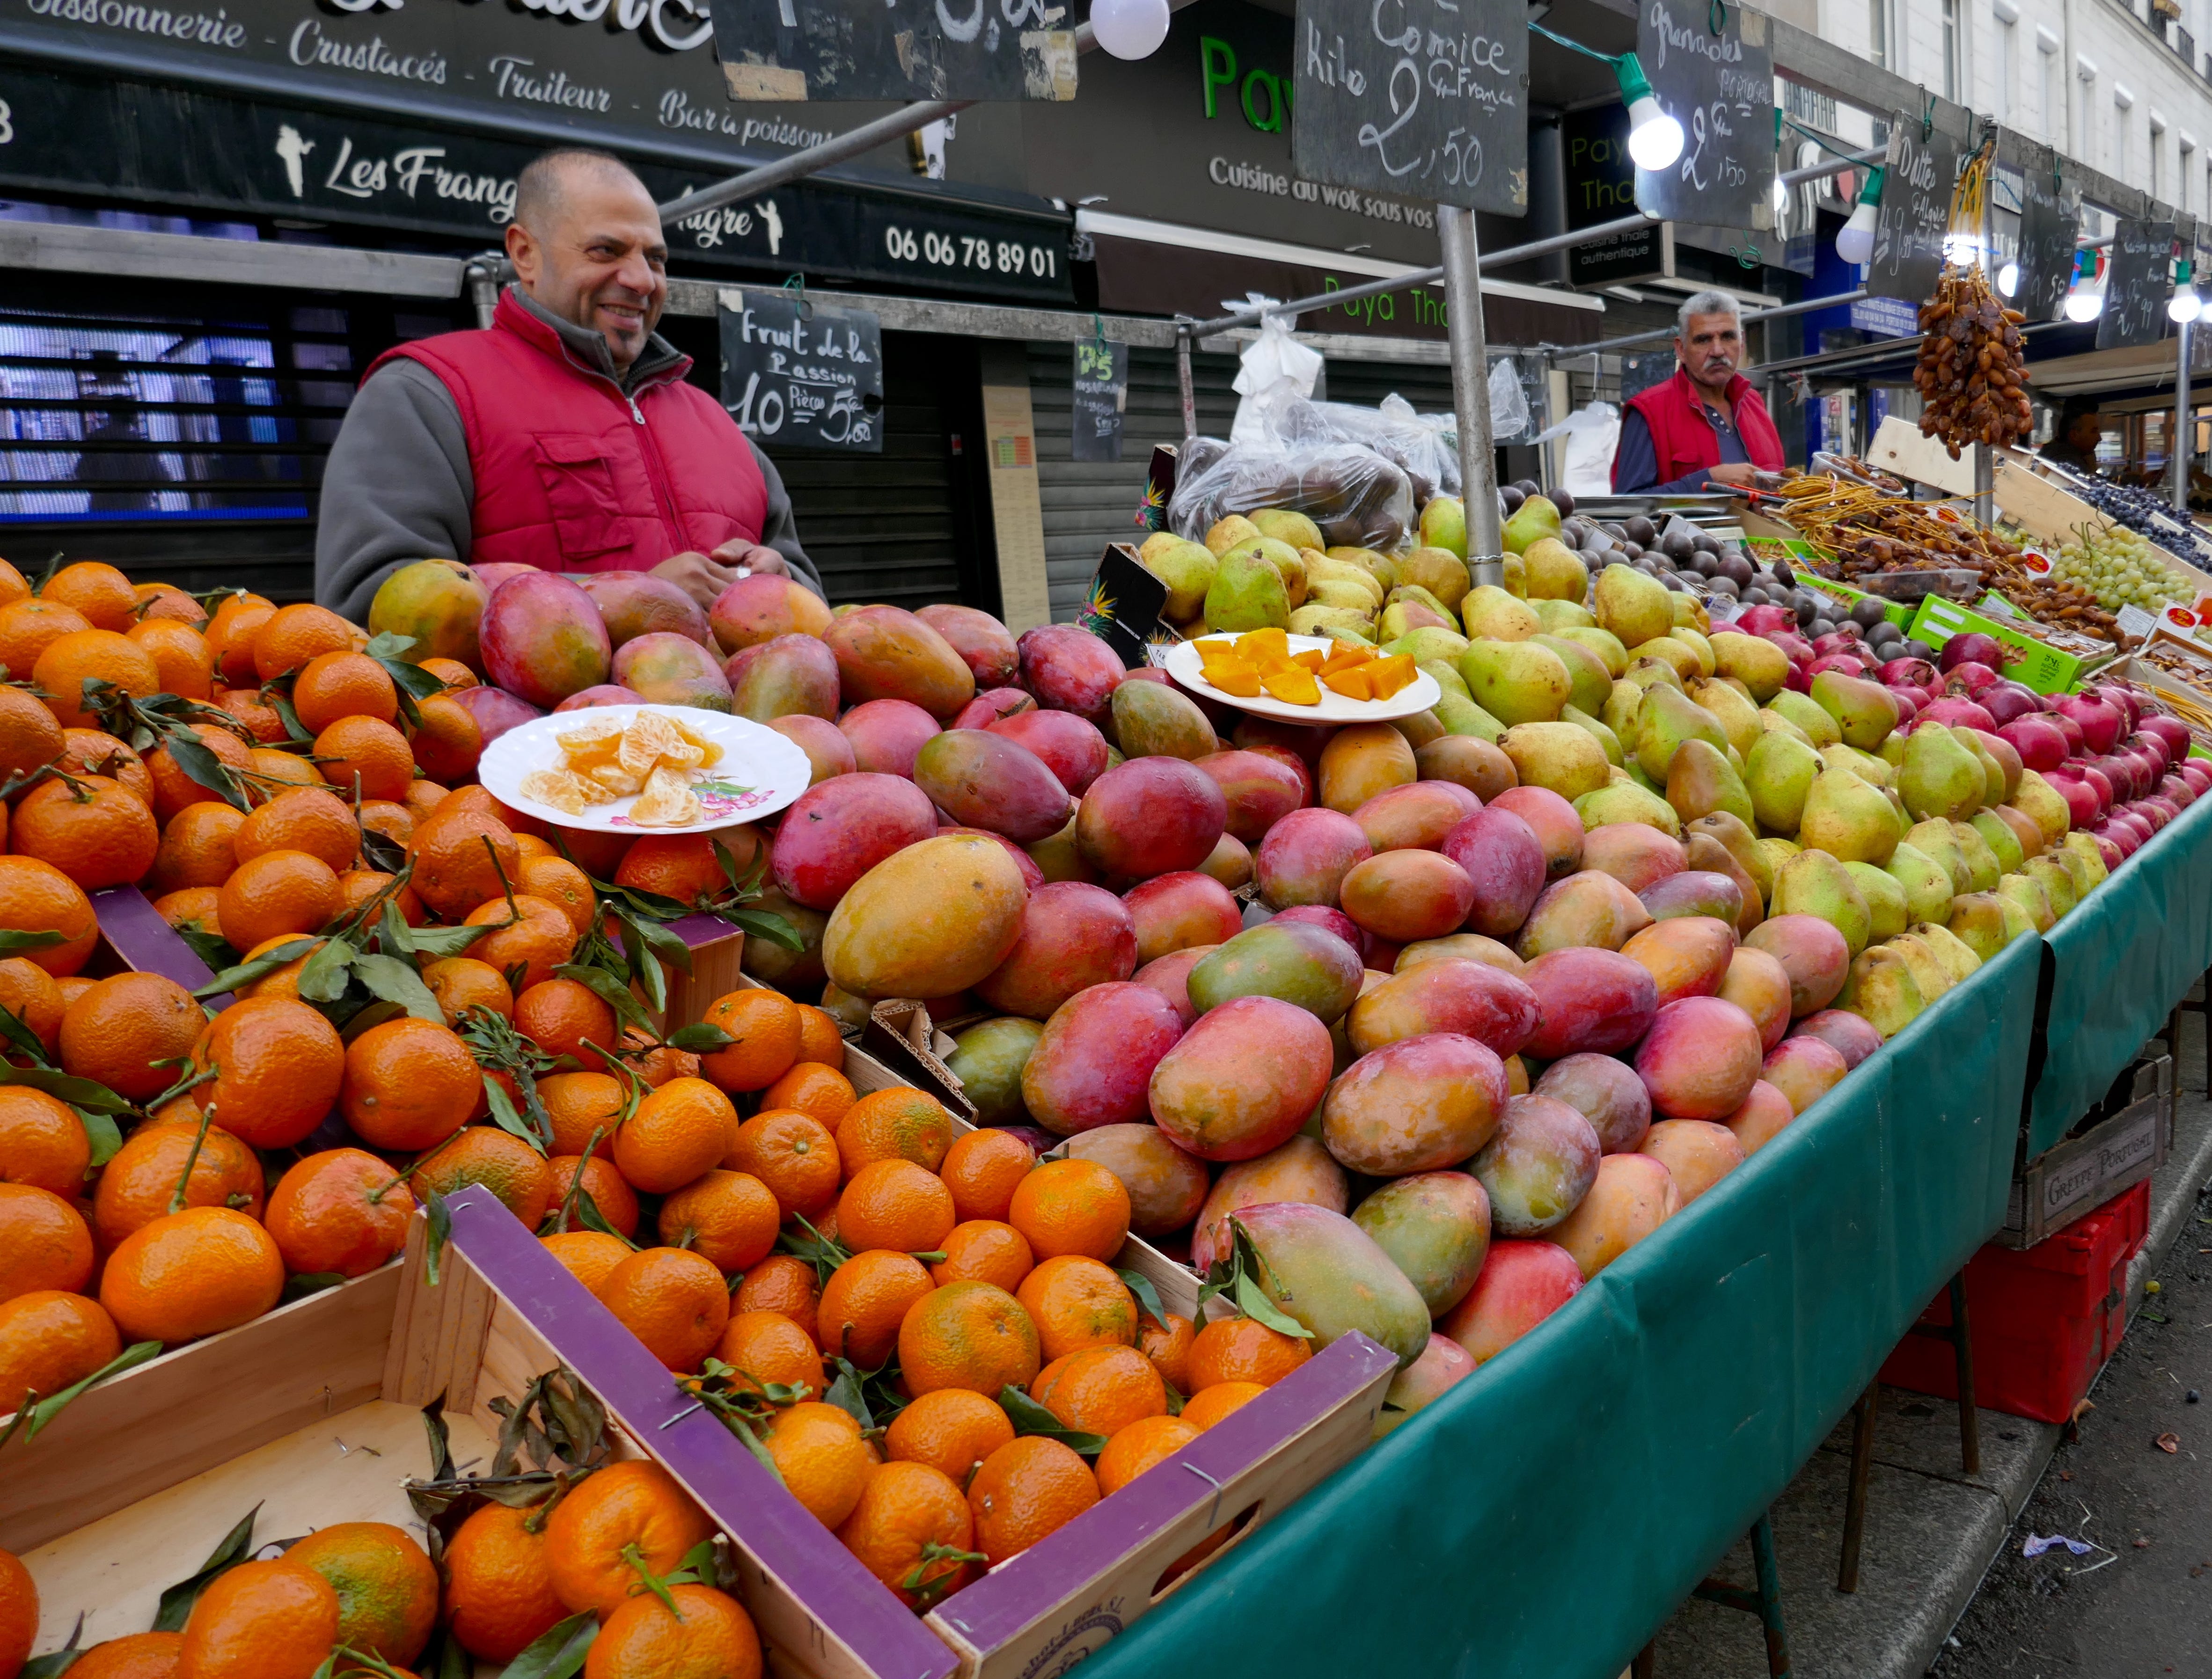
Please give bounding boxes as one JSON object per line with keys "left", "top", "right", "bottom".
{"left": 447, "top": 1186, "right": 956, "bottom": 1679}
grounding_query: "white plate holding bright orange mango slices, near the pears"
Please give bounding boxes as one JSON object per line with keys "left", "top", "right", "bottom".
{"left": 1168, "top": 628, "right": 1442, "bottom": 723}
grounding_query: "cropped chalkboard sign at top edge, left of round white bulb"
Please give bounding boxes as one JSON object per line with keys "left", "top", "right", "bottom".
{"left": 712, "top": 0, "right": 1075, "bottom": 102}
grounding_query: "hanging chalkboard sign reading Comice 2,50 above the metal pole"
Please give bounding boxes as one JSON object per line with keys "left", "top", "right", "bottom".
{"left": 1289, "top": 0, "right": 1529, "bottom": 217}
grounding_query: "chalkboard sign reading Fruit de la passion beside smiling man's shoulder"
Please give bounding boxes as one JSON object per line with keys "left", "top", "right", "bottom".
{"left": 721, "top": 290, "right": 883, "bottom": 456}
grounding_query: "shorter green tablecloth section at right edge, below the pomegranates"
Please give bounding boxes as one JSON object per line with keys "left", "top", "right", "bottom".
{"left": 2026, "top": 799, "right": 2212, "bottom": 1159}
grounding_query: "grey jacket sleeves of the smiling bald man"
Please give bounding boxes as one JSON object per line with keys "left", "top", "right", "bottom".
{"left": 314, "top": 321, "right": 823, "bottom": 624}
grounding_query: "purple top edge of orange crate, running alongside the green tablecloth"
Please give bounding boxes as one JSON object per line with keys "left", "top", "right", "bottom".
{"left": 938, "top": 1334, "right": 1398, "bottom": 1650}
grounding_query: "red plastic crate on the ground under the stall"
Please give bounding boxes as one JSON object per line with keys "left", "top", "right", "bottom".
{"left": 1882, "top": 1183, "right": 2150, "bottom": 1423}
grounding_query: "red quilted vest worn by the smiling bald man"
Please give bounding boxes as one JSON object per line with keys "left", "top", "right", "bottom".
{"left": 369, "top": 292, "right": 768, "bottom": 571}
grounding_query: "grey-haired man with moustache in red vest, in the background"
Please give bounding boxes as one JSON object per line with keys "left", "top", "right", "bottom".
{"left": 1612, "top": 292, "right": 1783, "bottom": 496}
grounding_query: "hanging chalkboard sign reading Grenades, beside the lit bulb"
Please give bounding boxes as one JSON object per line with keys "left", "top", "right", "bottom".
{"left": 1637, "top": 0, "right": 1774, "bottom": 232}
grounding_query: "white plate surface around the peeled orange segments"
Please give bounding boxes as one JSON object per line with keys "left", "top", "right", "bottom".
{"left": 476, "top": 706, "right": 814, "bottom": 834}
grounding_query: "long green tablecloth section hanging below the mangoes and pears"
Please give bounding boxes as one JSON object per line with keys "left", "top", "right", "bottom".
{"left": 1084, "top": 940, "right": 2042, "bottom": 1679}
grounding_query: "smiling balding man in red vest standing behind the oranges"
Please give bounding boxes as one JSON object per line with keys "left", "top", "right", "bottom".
{"left": 314, "top": 148, "right": 820, "bottom": 621}
